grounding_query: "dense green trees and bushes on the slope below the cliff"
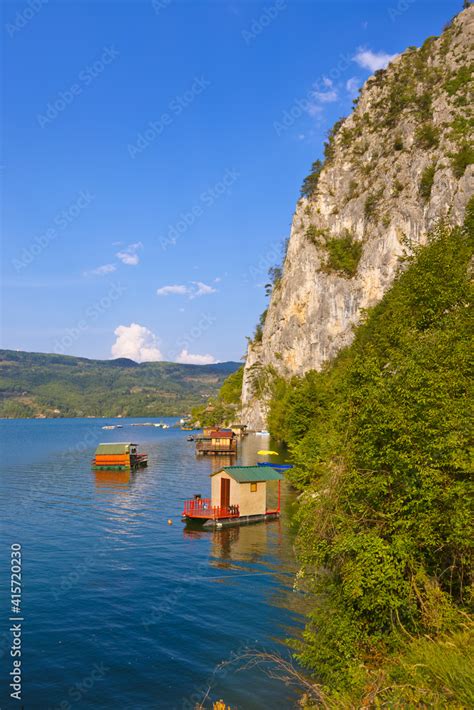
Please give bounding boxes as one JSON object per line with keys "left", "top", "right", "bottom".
{"left": 269, "top": 200, "right": 474, "bottom": 708}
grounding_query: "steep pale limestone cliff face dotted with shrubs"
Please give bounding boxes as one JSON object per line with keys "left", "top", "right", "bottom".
{"left": 242, "top": 6, "right": 474, "bottom": 429}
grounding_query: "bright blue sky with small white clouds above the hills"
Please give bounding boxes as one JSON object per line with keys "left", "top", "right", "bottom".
{"left": 2, "top": 0, "right": 462, "bottom": 363}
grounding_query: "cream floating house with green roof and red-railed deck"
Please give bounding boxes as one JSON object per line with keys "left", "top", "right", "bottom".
{"left": 183, "top": 466, "right": 284, "bottom": 527}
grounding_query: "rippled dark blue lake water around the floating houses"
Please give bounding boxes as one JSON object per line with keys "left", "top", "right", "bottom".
{"left": 0, "top": 419, "right": 300, "bottom": 710}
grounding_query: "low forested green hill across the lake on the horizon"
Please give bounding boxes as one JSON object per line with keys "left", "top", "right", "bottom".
{"left": 0, "top": 350, "right": 240, "bottom": 418}
